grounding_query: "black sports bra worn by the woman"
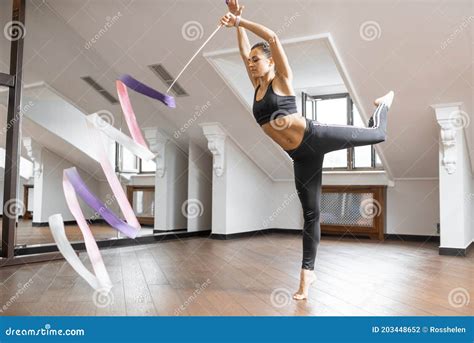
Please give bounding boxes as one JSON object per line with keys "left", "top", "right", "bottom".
{"left": 252, "top": 80, "right": 298, "bottom": 126}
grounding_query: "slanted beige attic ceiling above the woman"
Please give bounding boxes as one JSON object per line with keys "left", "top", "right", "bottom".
{"left": 0, "top": 0, "right": 474, "bottom": 179}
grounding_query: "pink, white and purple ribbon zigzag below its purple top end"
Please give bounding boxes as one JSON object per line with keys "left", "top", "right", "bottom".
{"left": 49, "top": 76, "right": 169, "bottom": 292}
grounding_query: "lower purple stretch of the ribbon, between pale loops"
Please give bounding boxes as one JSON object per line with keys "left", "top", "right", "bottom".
{"left": 64, "top": 167, "right": 137, "bottom": 238}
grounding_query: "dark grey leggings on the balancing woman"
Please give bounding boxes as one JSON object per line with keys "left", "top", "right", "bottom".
{"left": 286, "top": 104, "right": 388, "bottom": 270}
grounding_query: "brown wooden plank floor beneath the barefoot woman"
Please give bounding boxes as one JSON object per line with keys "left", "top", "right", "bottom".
{"left": 0, "top": 234, "right": 474, "bottom": 316}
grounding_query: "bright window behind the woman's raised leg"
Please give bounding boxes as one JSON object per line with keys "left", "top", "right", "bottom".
{"left": 302, "top": 93, "right": 382, "bottom": 170}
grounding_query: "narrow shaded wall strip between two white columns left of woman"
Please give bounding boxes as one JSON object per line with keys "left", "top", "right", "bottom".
{"left": 187, "top": 142, "right": 212, "bottom": 232}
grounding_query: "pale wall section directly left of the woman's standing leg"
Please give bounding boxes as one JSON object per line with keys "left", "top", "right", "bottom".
{"left": 212, "top": 137, "right": 302, "bottom": 234}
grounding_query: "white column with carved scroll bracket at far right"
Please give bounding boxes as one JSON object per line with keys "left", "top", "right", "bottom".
{"left": 432, "top": 103, "right": 472, "bottom": 253}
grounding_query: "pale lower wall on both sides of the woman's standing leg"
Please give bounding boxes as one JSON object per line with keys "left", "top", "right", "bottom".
{"left": 212, "top": 133, "right": 439, "bottom": 236}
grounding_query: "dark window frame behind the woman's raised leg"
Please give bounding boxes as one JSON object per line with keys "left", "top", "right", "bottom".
{"left": 301, "top": 92, "right": 384, "bottom": 171}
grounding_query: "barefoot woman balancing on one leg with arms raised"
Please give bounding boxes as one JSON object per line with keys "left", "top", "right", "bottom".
{"left": 221, "top": 0, "right": 394, "bottom": 300}
